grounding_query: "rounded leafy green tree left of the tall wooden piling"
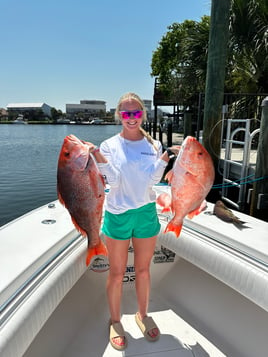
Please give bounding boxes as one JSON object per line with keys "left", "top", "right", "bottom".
{"left": 151, "top": 16, "right": 209, "bottom": 107}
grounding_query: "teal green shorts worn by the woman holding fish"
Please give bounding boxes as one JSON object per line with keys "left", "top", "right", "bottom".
{"left": 102, "top": 202, "right": 161, "bottom": 240}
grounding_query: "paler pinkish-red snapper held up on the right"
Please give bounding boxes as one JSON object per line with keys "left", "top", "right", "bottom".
{"left": 156, "top": 136, "right": 215, "bottom": 237}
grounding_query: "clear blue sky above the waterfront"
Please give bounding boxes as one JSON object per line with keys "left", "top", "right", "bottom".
{"left": 0, "top": 0, "right": 211, "bottom": 112}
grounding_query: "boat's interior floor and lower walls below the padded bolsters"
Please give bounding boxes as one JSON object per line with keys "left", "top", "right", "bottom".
{"left": 23, "top": 250, "right": 268, "bottom": 357}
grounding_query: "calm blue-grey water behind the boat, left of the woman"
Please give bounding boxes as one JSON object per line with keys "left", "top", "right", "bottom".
{"left": 0, "top": 124, "right": 121, "bottom": 226}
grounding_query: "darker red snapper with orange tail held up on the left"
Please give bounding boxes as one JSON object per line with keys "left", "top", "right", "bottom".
{"left": 57, "top": 135, "right": 107, "bottom": 265}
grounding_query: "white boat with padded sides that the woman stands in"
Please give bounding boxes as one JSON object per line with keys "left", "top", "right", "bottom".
{"left": 0, "top": 185, "right": 268, "bottom": 357}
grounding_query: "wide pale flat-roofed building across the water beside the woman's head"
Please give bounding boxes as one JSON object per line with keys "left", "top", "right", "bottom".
{"left": 66, "top": 100, "right": 106, "bottom": 119}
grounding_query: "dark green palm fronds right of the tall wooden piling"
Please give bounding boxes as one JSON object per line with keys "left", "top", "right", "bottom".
{"left": 226, "top": 0, "right": 268, "bottom": 93}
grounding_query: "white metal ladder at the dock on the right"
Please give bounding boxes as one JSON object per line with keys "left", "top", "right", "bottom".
{"left": 221, "top": 119, "right": 260, "bottom": 211}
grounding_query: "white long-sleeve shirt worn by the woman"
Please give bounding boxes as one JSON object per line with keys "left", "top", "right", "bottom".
{"left": 98, "top": 134, "right": 167, "bottom": 214}
